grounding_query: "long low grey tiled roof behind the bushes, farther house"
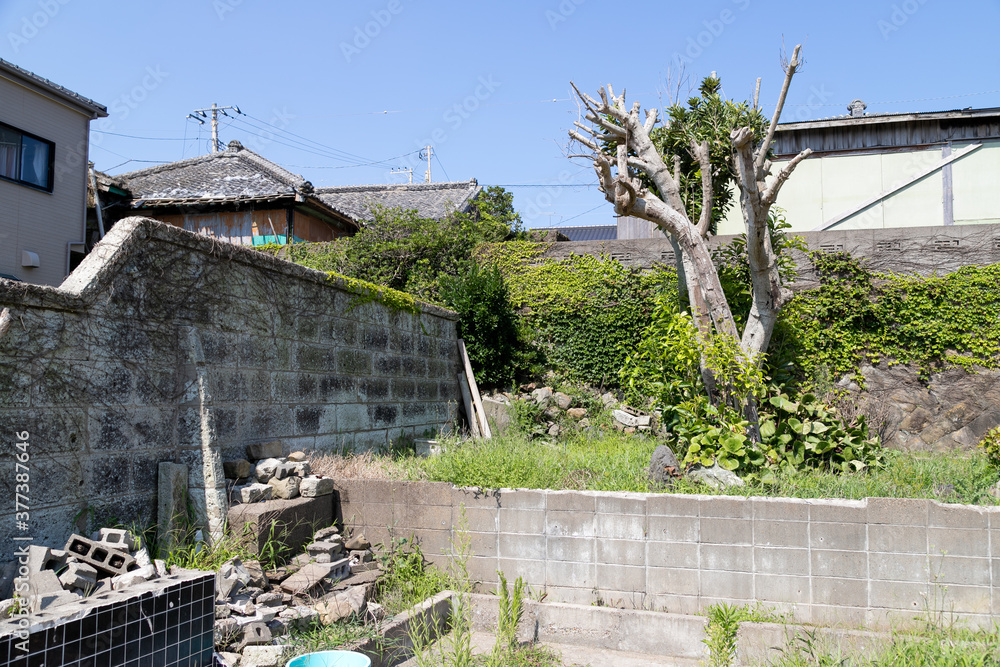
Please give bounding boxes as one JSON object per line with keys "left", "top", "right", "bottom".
{"left": 316, "top": 178, "right": 482, "bottom": 221}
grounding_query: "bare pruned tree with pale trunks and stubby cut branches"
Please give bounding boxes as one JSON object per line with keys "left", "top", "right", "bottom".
{"left": 569, "top": 45, "right": 812, "bottom": 418}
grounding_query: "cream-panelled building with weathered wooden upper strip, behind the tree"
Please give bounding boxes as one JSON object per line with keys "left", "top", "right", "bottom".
{"left": 719, "top": 100, "right": 1000, "bottom": 234}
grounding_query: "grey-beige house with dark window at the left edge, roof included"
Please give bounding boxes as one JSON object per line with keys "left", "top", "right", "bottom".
{"left": 0, "top": 60, "right": 108, "bottom": 285}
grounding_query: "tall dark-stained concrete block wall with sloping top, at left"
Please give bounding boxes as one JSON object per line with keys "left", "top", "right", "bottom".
{"left": 0, "top": 218, "right": 459, "bottom": 561}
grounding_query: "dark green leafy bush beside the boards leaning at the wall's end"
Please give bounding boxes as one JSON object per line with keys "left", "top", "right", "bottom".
{"left": 441, "top": 264, "right": 522, "bottom": 387}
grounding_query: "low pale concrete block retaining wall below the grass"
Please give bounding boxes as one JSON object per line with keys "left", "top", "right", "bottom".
{"left": 337, "top": 480, "right": 1000, "bottom": 627}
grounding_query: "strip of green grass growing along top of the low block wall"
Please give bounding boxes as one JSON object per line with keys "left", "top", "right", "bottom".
{"left": 370, "top": 432, "right": 998, "bottom": 505}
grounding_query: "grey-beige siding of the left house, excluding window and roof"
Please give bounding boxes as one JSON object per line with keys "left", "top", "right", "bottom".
{"left": 0, "top": 77, "right": 90, "bottom": 285}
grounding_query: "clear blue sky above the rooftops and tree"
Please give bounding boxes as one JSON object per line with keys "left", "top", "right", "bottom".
{"left": 0, "top": 0, "right": 1000, "bottom": 227}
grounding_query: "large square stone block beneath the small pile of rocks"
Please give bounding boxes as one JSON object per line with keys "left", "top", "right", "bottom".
{"left": 229, "top": 496, "right": 333, "bottom": 553}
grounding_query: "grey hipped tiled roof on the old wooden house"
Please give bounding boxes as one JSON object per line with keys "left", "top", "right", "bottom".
{"left": 118, "top": 141, "right": 312, "bottom": 206}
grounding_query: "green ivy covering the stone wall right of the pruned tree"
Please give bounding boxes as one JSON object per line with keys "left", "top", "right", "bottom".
{"left": 783, "top": 253, "right": 1000, "bottom": 386}
